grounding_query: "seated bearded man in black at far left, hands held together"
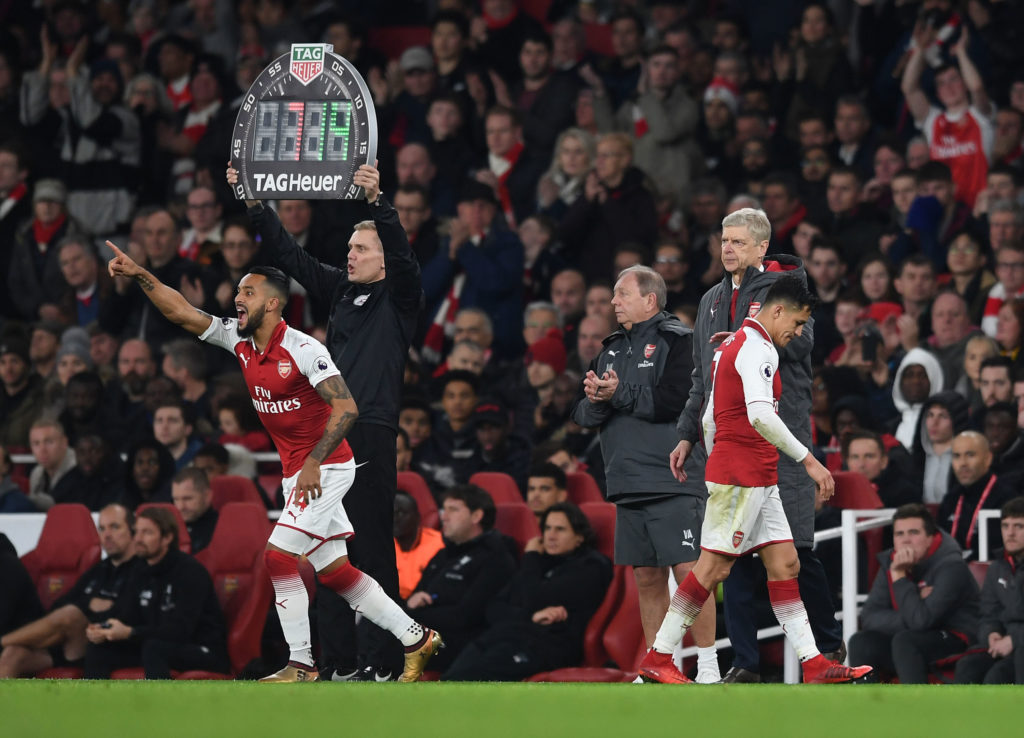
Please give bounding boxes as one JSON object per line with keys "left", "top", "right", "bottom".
{"left": 85, "top": 508, "right": 230, "bottom": 679}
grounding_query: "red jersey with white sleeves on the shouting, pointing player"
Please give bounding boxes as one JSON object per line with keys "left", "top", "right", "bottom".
{"left": 200, "top": 317, "right": 352, "bottom": 479}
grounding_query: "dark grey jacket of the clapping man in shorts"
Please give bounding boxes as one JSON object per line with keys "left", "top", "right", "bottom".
{"left": 572, "top": 311, "right": 707, "bottom": 503}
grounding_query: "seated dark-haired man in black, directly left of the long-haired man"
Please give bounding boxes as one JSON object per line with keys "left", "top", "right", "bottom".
{"left": 406, "top": 484, "right": 515, "bottom": 671}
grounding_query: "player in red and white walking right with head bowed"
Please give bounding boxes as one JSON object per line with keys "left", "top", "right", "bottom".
{"left": 640, "top": 276, "right": 871, "bottom": 684}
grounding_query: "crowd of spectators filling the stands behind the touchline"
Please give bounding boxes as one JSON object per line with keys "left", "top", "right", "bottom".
{"left": 6, "top": 0, "right": 1024, "bottom": 679}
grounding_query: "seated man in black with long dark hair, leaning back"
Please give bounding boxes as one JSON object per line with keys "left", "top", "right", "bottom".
{"left": 441, "top": 503, "right": 611, "bottom": 682}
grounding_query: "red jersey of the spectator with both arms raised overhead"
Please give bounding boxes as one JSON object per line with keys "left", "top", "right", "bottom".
{"left": 923, "top": 107, "right": 995, "bottom": 208}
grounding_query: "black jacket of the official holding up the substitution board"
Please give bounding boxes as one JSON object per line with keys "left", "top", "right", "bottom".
{"left": 249, "top": 196, "right": 424, "bottom": 431}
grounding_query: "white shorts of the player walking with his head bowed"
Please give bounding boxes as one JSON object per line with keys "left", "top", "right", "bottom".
{"left": 700, "top": 482, "right": 793, "bottom": 556}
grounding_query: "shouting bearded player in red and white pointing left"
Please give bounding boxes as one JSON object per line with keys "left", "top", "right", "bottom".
{"left": 106, "top": 238, "right": 441, "bottom": 682}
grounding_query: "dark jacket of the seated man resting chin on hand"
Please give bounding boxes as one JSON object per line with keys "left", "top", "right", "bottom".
{"left": 860, "top": 530, "right": 979, "bottom": 645}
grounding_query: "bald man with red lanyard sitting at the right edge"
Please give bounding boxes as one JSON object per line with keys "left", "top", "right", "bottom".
{"left": 936, "top": 431, "right": 1017, "bottom": 558}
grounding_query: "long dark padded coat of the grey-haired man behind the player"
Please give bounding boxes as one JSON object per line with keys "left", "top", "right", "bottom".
{"left": 676, "top": 254, "right": 814, "bottom": 548}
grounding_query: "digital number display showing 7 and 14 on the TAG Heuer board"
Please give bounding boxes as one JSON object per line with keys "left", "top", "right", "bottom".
{"left": 252, "top": 99, "right": 352, "bottom": 162}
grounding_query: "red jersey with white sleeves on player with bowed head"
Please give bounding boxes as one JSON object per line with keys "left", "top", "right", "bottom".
{"left": 705, "top": 317, "right": 782, "bottom": 487}
